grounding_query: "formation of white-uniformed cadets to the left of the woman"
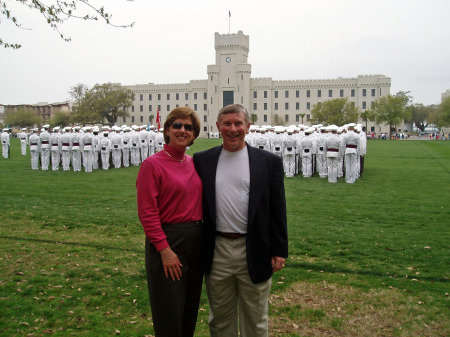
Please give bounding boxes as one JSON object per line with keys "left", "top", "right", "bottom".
{"left": 13, "top": 124, "right": 164, "bottom": 172}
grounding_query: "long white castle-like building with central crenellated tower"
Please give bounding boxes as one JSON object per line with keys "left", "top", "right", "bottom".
{"left": 124, "top": 31, "right": 394, "bottom": 137}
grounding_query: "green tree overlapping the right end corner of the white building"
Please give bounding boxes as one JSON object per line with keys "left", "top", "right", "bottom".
{"left": 372, "top": 91, "right": 411, "bottom": 138}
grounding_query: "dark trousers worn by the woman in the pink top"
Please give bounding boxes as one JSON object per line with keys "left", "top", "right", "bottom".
{"left": 145, "top": 222, "right": 203, "bottom": 337}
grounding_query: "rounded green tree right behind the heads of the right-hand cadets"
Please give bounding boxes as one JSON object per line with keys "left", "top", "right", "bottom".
{"left": 311, "top": 97, "right": 359, "bottom": 125}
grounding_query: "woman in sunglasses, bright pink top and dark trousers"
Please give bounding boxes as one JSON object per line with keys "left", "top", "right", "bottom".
{"left": 136, "top": 107, "right": 203, "bottom": 337}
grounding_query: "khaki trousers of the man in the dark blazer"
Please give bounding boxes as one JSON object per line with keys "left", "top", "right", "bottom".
{"left": 205, "top": 236, "right": 272, "bottom": 337}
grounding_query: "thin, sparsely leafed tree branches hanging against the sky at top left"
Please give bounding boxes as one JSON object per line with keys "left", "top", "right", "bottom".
{"left": 0, "top": 0, "right": 134, "bottom": 49}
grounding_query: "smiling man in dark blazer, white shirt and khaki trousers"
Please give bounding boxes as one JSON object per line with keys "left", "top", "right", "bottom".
{"left": 194, "top": 104, "right": 288, "bottom": 337}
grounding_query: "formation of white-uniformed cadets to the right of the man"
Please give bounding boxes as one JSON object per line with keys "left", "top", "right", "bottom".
{"left": 245, "top": 123, "right": 367, "bottom": 183}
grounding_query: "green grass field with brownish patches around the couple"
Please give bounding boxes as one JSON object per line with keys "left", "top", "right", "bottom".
{"left": 0, "top": 139, "right": 450, "bottom": 336}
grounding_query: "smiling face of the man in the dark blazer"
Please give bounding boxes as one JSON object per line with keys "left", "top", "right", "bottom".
{"left": 216, "top": 112, "right": 250, "bottom": 152}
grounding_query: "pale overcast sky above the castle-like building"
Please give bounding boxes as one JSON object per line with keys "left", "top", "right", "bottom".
{"left": 0, "top": 0, "right": 450, "bottom": 105}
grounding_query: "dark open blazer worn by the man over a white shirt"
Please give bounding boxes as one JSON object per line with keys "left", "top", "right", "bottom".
{"left": 194, "top": 145, "right": 288, "bottom": 283}
